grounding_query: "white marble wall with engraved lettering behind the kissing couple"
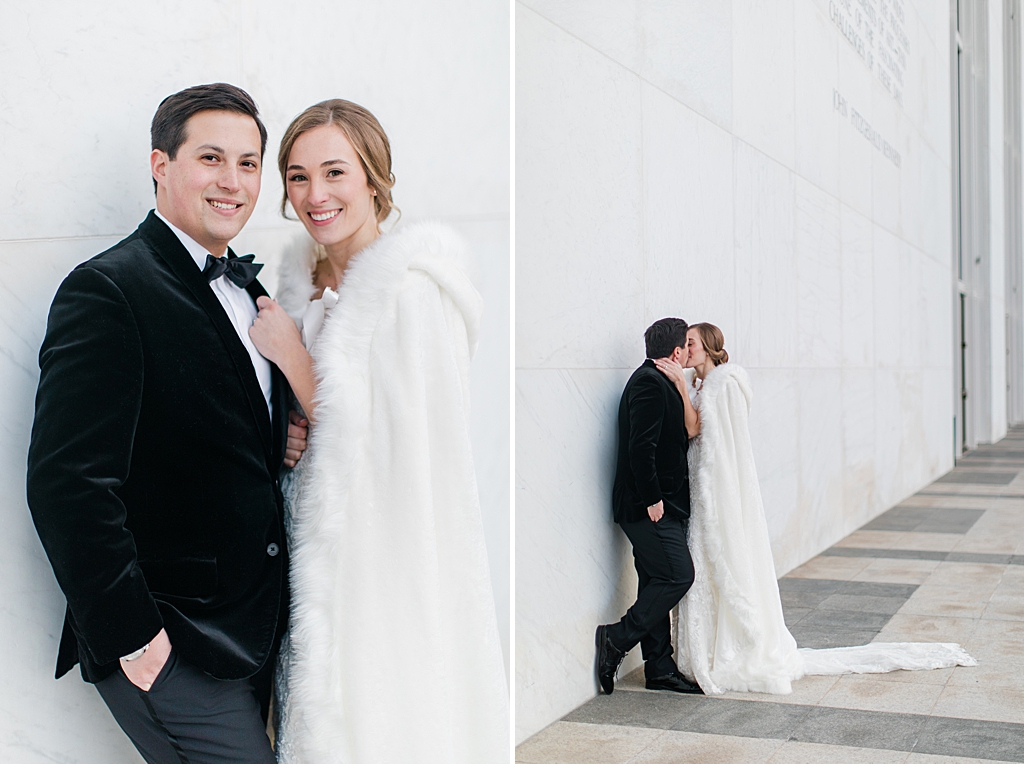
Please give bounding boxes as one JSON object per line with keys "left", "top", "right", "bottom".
{"left": 515, "top": 0, "right": 978, "bottom": 740}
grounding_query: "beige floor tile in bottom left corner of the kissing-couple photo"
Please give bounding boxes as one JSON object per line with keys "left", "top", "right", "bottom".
{"left": 515, "top": 722, "right": 666, "bottom": 764}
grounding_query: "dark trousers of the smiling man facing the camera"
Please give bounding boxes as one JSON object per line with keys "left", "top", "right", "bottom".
{"left": 96, "top": 649, "right": 275, "bottom": 764}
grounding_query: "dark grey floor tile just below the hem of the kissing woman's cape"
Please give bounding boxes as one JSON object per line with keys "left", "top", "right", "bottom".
{"left": 672, "top": 697, "right": 812, "bottom": 740}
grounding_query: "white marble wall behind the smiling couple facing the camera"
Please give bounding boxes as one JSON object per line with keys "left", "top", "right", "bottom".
{"left": 0, "top": 0, "right": 511, "bottom": 764}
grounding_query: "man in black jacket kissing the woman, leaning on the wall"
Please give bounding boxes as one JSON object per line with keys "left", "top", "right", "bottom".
{"left": 597, "top": 319, "right": 700, "bottom": 694}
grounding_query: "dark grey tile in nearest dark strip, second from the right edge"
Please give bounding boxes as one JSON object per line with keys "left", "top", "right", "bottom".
{"left": 792, "top": 707, "right": 928, "bottom": 751}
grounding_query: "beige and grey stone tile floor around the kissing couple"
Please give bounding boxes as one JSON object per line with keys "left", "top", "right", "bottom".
{"left": 516, "top": 428, "right": 1024, "bottom": 764}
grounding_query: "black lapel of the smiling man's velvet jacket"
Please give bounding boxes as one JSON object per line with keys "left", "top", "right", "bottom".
{"left": 139, "top": 212, "right": 280, "bottom": 460}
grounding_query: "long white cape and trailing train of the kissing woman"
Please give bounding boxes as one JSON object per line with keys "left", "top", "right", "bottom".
{"left": 677, "top": 363, "right": 977, "bottom": 694}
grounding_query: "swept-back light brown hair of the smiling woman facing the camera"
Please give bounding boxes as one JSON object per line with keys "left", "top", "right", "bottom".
{"left": 278, "top": 98, "right": 397, "bottom": 225}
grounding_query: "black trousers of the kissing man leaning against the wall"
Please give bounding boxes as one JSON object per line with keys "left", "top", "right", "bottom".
{"left": 608, "top": 515, "right": 693, "bottom": 679}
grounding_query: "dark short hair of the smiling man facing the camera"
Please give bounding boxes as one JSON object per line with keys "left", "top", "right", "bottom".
{"left": 150, "top": 82, "right": 266, "bottom": 187}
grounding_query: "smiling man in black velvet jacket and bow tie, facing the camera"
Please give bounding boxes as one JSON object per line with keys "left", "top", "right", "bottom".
{"left": 28, "top": 84, "right": 304, "bottom": 762}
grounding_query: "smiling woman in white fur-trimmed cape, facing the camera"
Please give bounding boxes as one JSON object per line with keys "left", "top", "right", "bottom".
{"left": 244, "top": 99, "right": 509, "bottom": 764}
